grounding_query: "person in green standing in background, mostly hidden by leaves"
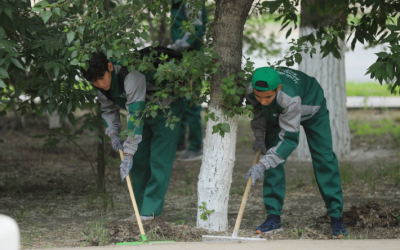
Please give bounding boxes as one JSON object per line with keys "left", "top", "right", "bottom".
{"left": 171, "top": 0, "right": 207, "bottom": 161}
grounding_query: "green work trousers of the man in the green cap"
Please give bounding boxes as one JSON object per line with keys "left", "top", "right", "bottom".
{"left": 263, "top": 108, "right": 343, "bottom": 217}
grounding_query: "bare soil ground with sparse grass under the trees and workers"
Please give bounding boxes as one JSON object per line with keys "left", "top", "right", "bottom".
{"left": 0, "top": 110, "right": 400, "bottom": 249}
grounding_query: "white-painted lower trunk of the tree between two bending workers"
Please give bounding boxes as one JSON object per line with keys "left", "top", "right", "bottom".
{"left": 197, "top": 108, "right": 237, "bottom": 231}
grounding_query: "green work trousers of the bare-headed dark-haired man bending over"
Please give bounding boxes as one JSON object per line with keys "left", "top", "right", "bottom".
{"left": 130, "top": 99, "right": 184, "bottom": 216}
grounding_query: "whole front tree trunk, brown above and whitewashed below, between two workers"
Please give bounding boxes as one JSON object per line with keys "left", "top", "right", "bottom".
{"left": 197, "top": 0, "right": 253, "bottom": 231}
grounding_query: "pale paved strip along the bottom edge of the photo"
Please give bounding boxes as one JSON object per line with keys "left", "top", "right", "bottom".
{"left": 32, "top": 240, "right": 400, "bottom": 250}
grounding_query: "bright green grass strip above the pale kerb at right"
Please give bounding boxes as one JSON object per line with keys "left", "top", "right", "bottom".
{"left": 346, "top": 82, "right": 398, "bottom": 96}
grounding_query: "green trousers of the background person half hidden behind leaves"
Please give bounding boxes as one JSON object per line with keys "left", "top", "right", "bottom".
{"left": 178, "top": 99, "right": 203, "bottom": 152}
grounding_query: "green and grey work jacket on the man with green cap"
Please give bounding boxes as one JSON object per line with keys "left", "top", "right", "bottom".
{"left": 247, "top": 67, "right": 326, "bottom": 168}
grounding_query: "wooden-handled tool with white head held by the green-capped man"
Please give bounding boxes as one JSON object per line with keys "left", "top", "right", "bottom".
{"left": 202, "top": 148, "right": 266, "bottom": 241}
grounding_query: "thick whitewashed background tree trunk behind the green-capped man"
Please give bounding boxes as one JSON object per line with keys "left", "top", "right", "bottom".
{"left": 297, "top": 0, "right": 350, "bottom": 159}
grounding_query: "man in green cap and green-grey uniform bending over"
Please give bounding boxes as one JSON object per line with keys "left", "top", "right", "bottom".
{"left": 246, "top": 67, "right": 347, "bottom": 238}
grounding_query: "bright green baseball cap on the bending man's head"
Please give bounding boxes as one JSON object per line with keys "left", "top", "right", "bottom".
{"left": 251, "top": 67, "right": 282, "bottom": 91}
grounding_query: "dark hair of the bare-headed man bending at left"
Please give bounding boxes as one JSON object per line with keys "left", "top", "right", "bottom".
{"left": 81, "top": 51, "right": 108, "bottom": 82}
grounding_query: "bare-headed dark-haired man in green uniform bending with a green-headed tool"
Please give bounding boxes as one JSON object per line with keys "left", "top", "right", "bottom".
{"left": 81, "top": 52, "right": 184, "bottom": 220}
